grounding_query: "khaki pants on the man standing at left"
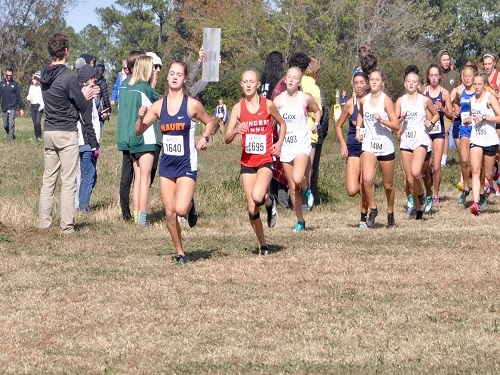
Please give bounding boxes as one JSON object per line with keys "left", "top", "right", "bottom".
{"left": 39, "top": 131, "right": 79, "bottom": 233}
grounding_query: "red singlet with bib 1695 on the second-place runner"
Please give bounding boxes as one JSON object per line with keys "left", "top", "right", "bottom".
{"left": 240, "top": 98, "right": 273, "bottom": 168}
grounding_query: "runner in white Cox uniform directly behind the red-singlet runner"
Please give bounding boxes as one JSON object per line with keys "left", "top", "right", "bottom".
{"left": 273, "top": 67, "right": 321, "bottom": 232}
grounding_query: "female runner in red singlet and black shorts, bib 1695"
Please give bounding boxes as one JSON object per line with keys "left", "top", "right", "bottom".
{"left": 224, "top": 69, "right": 286, "bottom": 255}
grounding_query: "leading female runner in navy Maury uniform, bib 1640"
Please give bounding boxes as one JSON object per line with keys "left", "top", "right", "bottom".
{"left": 135, "top": 61, "right": 213, "bottom": 265}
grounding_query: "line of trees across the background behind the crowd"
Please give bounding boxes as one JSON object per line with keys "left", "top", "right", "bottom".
{"left": 0, "top": 0, "right": 500, "bottom": 106}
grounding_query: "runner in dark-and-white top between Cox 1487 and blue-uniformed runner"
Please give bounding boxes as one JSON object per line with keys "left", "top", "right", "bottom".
{"left": 425, "top": 63, "right": 453, "bottom": 207}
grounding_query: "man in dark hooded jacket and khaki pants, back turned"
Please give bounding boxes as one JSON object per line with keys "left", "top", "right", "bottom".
{"left": 39, "top": 34, "right": 98, "bottom": 233}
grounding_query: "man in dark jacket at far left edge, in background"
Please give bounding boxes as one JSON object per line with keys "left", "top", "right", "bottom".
{"left": 0, "top": 68, "right": 24, "bottom": 140}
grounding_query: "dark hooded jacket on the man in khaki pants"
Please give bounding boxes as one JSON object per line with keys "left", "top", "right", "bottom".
{"left": 40, "top": 64, "right": 87, "bottom": 131}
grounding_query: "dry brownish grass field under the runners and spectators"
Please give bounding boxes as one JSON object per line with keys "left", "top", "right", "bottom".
{"left": 0, "top": 117, "right": 500, "bottom": 374}
